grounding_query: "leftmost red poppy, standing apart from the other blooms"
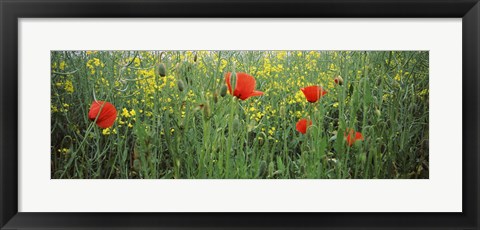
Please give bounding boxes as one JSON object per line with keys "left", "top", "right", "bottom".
{"left": 88, "top": 101, "right": 117, "bottom": 129}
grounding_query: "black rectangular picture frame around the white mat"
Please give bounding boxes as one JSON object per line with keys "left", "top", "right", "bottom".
{"left": 0, "top": 0, "right": 480, "bottom": 229}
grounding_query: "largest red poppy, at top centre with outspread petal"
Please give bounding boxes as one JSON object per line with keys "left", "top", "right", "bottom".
{"left": 225, "top": 72, "right": 263, "bottom": 100}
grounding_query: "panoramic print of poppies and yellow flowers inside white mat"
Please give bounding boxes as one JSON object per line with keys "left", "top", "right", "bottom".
{"left": 51, "top": 51, "right": 429, "bottom": 179}
